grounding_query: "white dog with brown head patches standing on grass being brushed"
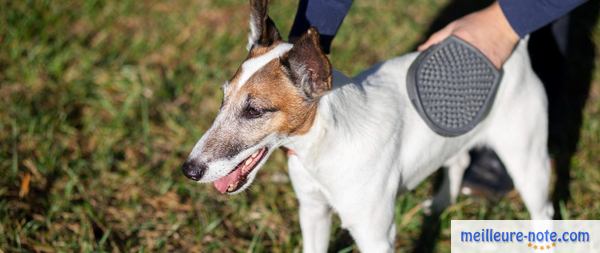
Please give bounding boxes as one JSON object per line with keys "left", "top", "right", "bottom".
{"left": 182, "top": 0, "right": 553, "bottom": 252}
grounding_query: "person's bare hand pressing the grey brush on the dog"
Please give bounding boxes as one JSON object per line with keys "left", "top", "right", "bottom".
{"left": 418, "top": 2, "right": 519, "bottom": 68}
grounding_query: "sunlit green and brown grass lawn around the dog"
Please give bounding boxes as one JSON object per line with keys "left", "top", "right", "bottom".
{"left": 0, "top": 0, "right": 600, "bottom": 252}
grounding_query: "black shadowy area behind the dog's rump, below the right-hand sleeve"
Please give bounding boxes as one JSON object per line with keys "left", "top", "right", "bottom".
{"left": 529, "top": 1, "right": 600, "bottom": 219}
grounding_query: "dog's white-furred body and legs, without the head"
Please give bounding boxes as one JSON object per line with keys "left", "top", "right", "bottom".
{"left": 284, "top": 38, "right": 553, "bottom": 252}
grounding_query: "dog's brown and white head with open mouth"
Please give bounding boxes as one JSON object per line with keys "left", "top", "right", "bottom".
{"left": 182, "top": 0, "right": 331, "bottom": 194}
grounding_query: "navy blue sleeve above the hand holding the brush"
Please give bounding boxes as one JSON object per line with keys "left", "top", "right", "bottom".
{"left": 498, "top": 0, "right": 585, "bottom": 38}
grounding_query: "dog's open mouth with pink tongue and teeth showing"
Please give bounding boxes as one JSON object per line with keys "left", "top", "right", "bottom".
{"left": 214, "top": 147, "right": 268, "bottom": 193}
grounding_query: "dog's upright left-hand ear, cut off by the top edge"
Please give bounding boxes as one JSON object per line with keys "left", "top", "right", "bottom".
{"left": 247, "top": 0, "right": 281, "bottom": 50}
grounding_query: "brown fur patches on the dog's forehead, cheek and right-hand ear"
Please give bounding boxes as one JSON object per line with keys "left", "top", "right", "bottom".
{"left": 230, "top": 28, "right": 332, "bottom": 135}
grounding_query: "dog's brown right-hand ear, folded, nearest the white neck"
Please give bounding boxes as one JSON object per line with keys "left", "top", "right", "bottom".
{"left": 282, "top": 27, "right": 332, "bottom": 100}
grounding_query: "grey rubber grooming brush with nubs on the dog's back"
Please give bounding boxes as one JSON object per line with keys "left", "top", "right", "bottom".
{"left": 406, "top": 36, "right": 502, "bottom": 137}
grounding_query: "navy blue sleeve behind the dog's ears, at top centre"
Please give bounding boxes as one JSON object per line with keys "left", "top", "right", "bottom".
{"left": 289, "top": 0, "right": 352, "bottom": 53}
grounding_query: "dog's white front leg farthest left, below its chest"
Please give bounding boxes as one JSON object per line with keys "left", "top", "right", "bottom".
{"left": 288, "top": 155, "right": 331, "bottom": 253}
